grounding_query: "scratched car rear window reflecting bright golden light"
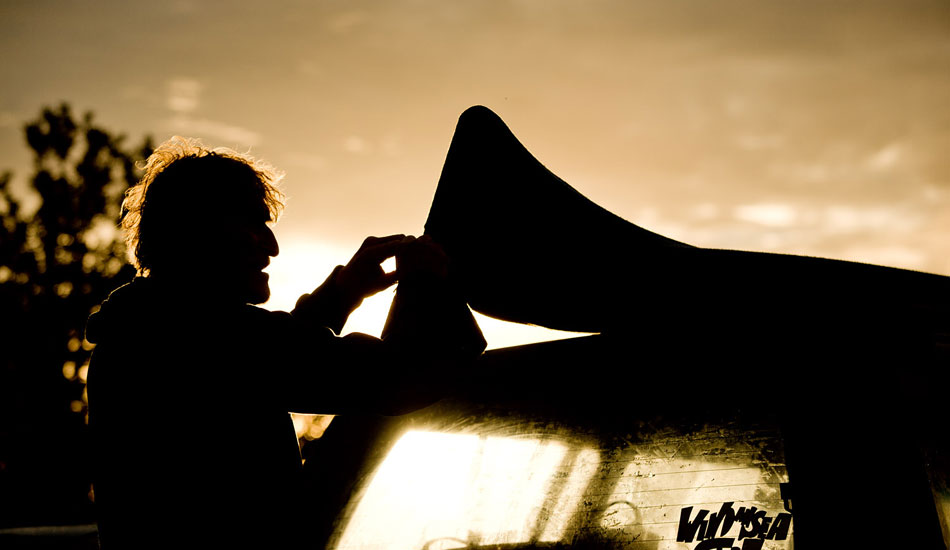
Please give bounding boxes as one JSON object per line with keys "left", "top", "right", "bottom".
{"left": 331, "top": 417, "right": 793, "bottom": 550}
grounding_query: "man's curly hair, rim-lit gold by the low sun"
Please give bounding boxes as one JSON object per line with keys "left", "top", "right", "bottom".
{"left": 122, "top": 136, "right": 284, "bottom": 276}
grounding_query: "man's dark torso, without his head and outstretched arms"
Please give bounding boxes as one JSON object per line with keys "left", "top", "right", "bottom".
{"left": 89, "top": 279, "right": 310, "bottom": 548}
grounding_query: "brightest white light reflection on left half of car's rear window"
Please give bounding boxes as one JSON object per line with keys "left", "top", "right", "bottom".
{"left": 336, "top": 431, "right": 598, "bottom": 550}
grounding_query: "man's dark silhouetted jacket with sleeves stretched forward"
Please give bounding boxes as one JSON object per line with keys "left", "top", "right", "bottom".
{"left": 87, "top": 272, "right": 476, "bottom": 550}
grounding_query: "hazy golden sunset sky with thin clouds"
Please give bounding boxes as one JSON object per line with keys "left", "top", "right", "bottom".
{"left": 0, "top": 0, "right": 950, "bottom": 347}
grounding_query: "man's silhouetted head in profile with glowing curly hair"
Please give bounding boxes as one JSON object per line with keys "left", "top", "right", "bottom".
{"left": 122, "top": 137, "right": 283, "bottom": 304}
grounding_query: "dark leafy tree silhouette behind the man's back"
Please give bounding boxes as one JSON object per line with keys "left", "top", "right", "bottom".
{"left": 0, "top": 104, "right": 151, "bottom": 527}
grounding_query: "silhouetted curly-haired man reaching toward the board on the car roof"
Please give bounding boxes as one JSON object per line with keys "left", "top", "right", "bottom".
{"left": 87, "top": 138, "right": 480, "bottom": 550}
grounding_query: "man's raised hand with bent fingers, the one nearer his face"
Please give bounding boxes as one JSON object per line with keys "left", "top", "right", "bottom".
{"left": 336, "top": 235, "right": 416, "bottom": 305}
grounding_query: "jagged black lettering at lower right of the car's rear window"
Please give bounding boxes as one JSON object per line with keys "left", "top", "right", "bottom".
{"left": 676, "top": 502, "right": 792, "bottom": 550}
